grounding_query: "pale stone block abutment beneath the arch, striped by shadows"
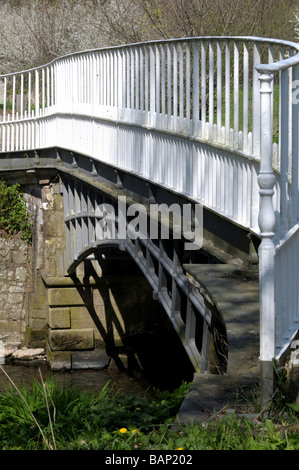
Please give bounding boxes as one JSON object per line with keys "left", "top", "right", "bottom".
{"left": 43, "top": 276, "right": 157, "bottom": 370}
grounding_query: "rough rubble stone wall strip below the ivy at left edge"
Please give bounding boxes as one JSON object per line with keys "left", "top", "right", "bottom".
{"left": 0, "top": 236, "right": 32, "bottom": 349}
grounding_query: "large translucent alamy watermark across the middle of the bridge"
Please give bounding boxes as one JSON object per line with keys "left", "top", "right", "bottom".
{"left": 95, "top": 196, "right": 203, "bottom": 250}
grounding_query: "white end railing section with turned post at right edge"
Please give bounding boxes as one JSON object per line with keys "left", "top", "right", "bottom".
{"left": 257, "top": 54, "right": 299, "bottom": 362}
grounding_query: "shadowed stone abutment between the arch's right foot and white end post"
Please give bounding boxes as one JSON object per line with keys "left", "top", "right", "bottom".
{"left": 179, "top": 264, "right": 259, "bottom": 422}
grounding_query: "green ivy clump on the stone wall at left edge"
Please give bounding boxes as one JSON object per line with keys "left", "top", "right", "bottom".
{"left": 0, "top": 180, "right": 32, "bottom": 243}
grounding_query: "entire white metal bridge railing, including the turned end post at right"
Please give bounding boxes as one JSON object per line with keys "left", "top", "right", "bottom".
{"left": 0, "top": 37, "right": 299, "bottom": 366}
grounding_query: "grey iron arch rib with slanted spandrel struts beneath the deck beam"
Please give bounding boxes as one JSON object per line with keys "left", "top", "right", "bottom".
{"left": 61, "top": 174, "right": 227, "bottom": 373}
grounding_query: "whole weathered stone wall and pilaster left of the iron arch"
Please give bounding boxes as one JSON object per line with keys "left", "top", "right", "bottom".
{"left": 0, "top": 181, "right": 64, "bottom": 351}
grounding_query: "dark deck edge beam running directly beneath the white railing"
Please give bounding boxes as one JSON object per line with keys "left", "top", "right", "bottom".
{"left": 0, "top": 148, "right": 260, "bottom": 269}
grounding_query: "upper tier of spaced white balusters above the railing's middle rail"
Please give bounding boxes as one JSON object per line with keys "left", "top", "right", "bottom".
{"left": 0, "top": 37, "right": 298, "bottom": 156}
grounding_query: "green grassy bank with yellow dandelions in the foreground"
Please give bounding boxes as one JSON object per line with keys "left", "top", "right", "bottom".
{"left": 0, "top": 371, "right": 299, "bottom": 450}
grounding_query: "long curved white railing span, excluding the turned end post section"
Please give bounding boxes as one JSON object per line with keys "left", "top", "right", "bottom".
{"left": 0, "top": 37, "right": 297, "bottom": 232}
